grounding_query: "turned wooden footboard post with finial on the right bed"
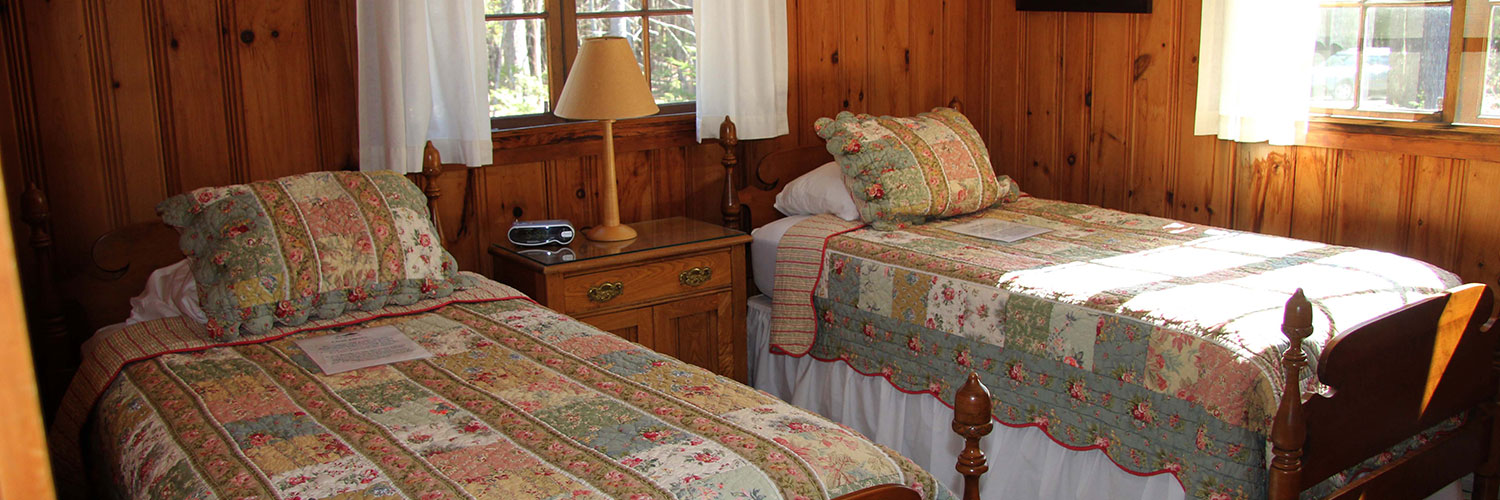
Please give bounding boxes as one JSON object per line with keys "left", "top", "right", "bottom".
{"left": 1271, "top": 288, "right": 1313, "bottom": 500}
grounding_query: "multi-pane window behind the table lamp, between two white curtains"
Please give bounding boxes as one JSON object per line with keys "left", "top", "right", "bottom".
{"left": 485, "top": 0, "right": 698, "bottom": 128}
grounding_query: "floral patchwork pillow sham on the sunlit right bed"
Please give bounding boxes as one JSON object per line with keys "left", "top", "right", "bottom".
{"left": 815, "top": 108, "right": 1020, "bottom": 231}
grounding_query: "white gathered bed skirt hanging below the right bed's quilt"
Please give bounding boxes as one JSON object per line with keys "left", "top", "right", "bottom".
{"left": 746, "top": 295, "right": 1463, "bottom": 500}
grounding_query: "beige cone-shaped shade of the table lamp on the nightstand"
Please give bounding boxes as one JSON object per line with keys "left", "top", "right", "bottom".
{"left": 552, "top": 36, "right": 660, "bottom": 120}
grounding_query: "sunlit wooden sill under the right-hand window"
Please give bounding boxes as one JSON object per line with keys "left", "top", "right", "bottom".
{"left": 1305, "top": 117, "right": 1500, "bottom": 162}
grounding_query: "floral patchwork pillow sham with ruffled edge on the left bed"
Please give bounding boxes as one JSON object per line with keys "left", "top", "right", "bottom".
{"left": 156, "top": 171, "right": 459, "bottom": 336}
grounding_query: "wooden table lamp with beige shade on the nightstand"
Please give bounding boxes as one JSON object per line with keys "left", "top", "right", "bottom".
{"left": 552, "top": 36, "right": 660, "bottom": 242}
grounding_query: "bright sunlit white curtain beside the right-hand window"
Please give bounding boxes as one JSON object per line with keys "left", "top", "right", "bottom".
{"left": 1194, "top": 0, "right": 1319, "bottom": 146}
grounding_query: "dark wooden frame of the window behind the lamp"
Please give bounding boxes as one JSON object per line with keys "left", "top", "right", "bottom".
{"left": 485, "top": 0, "right": 698, "bottom": 132}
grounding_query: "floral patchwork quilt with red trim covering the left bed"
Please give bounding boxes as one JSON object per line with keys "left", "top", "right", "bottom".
{"left": 61, "top": 276, "right": 953, "bottom": 500}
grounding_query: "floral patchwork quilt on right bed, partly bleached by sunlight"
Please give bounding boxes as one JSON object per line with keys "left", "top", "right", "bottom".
{"left": 771, "top": 197, "right": 1461, "bottom": 498}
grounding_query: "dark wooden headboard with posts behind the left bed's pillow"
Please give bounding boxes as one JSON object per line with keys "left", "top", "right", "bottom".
{"left": 21, "top": 143, "right": 443, "bottom": 417}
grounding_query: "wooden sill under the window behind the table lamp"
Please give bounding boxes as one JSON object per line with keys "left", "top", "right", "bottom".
{"left": 491, "top": 113, "right": 698, "bottom": 165}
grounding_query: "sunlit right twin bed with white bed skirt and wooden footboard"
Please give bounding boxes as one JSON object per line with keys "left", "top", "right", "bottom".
{"left": 711, "top": 102, "right": 1500, "bottom": 498}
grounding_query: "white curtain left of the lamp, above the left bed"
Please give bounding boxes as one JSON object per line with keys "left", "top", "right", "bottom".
{"left": 356, "top": 0, "right": 494, "bottom": 173}
